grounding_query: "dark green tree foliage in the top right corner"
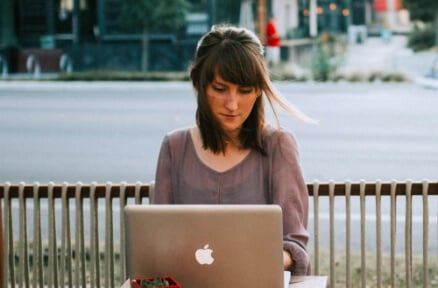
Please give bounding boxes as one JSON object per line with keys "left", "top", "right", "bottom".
{"left": 403, "top": 0, "right": 438, "bottom": 47}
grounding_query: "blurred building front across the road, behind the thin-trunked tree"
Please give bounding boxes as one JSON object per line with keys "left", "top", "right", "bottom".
{"left": 0, "top": 0, "right": 406, "bottom": 73}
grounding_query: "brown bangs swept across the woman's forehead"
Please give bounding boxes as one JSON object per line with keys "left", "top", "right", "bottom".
{"left": 205, "top": 40, "right": 263, "bottom": 88}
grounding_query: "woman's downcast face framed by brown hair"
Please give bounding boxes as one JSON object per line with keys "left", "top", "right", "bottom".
{"left": 206, "top": 74, "right": 261, "bottom": 136}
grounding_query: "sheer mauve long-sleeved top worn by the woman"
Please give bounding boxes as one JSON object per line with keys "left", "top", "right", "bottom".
{"left": 154, "top": 125, "right": 310, "bottom": 275}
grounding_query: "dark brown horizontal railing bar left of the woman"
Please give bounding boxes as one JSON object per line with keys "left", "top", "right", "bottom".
{"left": 0, "top": 183, "right": 150, "bottom": 199}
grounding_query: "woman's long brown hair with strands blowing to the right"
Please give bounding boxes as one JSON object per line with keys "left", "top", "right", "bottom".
{"left": 190, "top": 25, "right": 314, "bottom": 155}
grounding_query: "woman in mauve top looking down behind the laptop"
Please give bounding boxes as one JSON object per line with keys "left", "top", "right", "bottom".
{"left": 154, "top": 26, "right": 310, "bottom": 275}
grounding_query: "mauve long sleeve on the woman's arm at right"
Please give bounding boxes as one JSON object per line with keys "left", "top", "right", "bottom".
{"left": 270, "top": 131, "right": 311, "bottom": 275}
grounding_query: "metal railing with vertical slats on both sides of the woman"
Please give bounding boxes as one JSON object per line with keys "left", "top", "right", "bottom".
{"left": 0, "top": 181, "right": 438, "bottom": 287}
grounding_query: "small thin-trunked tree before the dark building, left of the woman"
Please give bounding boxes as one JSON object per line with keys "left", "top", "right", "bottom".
{"left": 121, "top": 0, "right": 190, "bottom": 71}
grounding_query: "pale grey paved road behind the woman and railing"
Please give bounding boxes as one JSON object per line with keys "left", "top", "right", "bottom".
{"left": 0, "top": 82, "right": 438, "bottom": 252}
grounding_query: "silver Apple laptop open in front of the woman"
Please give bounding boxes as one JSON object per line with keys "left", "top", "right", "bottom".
{"left": 125, "top": 205, "right": 284, "bottom": 288}
